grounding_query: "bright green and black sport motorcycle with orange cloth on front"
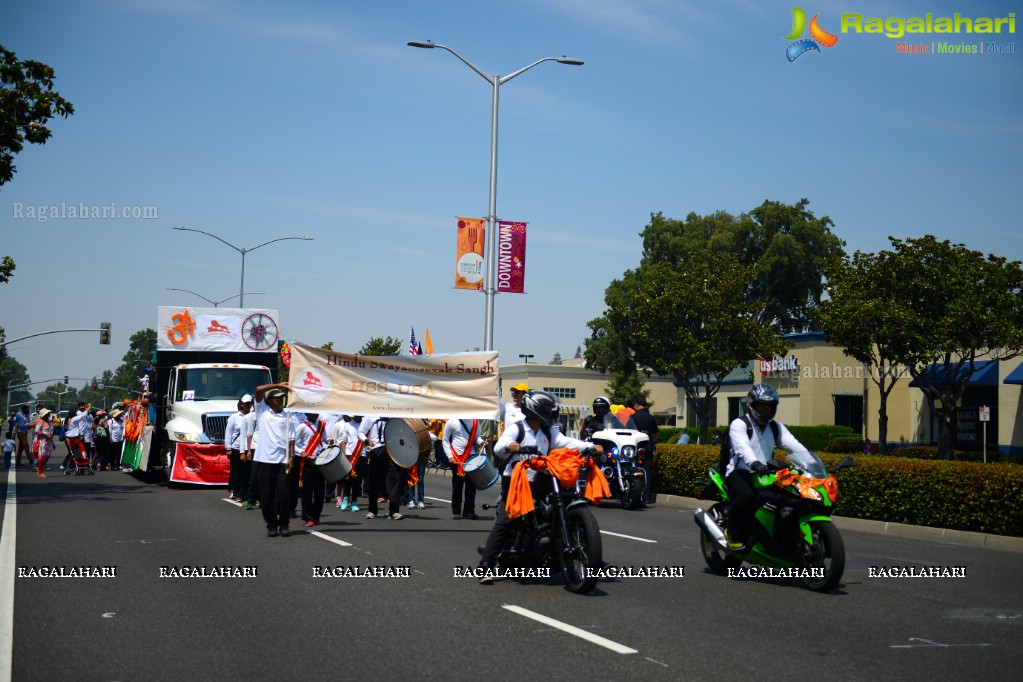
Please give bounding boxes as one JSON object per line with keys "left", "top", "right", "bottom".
{"left": 696, "top": 452, "right": 853, "bottom": 592}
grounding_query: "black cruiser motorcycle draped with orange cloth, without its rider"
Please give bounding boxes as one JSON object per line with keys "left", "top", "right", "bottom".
{"left": 479, "top": 447, "right": 604, "bottom": 594}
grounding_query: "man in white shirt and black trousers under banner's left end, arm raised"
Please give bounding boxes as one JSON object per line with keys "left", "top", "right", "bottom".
{"left": 253, "top": 381, "right": 292, "bottom": 538}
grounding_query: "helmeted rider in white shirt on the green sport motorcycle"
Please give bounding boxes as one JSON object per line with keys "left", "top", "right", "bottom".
{"left": 725, "top": 383, "right": 806, "bottom": 550}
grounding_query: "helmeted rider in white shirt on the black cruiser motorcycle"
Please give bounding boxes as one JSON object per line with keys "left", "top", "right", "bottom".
{"left": 480, "top": 391, "right": 597, "bottom": 584}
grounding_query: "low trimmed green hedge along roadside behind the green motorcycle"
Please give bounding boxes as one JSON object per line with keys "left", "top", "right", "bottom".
{"left": 654, "top": 445, "right": 1023, "bottom": 537}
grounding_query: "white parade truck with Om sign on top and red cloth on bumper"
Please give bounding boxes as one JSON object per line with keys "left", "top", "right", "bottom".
{"left": 136, "top": 306, "right": 278, "bottom": 486}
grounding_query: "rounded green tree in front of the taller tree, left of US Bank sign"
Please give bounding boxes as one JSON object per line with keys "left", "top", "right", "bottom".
{"left": 605, "top": 254, "right": 786, "bottom": 442}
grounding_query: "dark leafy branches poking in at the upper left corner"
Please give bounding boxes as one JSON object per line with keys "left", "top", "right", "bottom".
{"left": 0, "top": 45, "right": 75, "bottom": 185}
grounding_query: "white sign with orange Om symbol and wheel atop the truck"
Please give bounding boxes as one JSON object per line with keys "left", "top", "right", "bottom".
{"left": 157, "top": 306, "right": 278, "bottom": 352}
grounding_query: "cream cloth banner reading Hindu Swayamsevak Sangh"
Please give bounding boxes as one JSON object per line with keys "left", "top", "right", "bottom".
{"left": 287, "top": 343, "right": 498, "bottom": 419}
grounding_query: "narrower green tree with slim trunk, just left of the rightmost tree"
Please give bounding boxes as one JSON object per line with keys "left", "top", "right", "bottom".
{"left": 813, "top": 251, "right": 905, "bottom": 453}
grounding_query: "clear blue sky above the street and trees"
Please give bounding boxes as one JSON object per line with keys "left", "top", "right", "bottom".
{"left": 0, "top": 0, "right": 1023, "bottom": 392}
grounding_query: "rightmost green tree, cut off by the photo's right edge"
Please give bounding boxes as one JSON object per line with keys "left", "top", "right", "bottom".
{"left": 879, "top": 235, "right": 1023, "bottom": 459}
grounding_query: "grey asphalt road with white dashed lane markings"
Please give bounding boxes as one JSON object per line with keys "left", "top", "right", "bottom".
{"left": 0, "top": 459, "right": 1023, "bottom": 681}
